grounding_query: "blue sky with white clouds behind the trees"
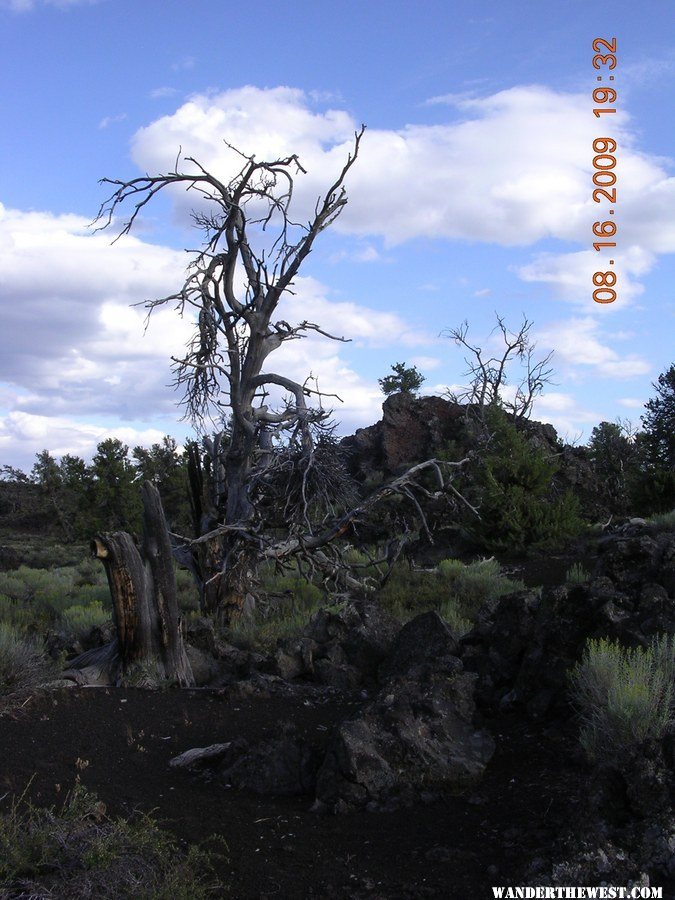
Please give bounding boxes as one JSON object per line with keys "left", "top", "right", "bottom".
{"left": 0, "top": 0, "right": 675, "bottom": 469}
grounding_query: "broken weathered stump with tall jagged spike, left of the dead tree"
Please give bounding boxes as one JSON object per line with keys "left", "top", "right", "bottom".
{"left": 92, "top": 482, "right": 194, "bottom": 687}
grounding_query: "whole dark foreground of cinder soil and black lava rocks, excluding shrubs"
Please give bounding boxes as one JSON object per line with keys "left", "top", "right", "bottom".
{"left": 0, "top": 523, "right": 675, "bottom": 900}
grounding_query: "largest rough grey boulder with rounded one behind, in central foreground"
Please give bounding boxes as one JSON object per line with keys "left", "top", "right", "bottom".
{"left": 316, "top": 613, "right": 494, "bottom": 811}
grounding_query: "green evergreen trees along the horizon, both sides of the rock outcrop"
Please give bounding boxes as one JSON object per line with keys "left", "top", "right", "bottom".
{"left": 0, "top": 365, "right": 675, "bottom": 551}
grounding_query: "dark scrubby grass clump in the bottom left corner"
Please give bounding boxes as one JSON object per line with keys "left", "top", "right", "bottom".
{"left": 0, "top": 783, "right": 224, "bottom": 900}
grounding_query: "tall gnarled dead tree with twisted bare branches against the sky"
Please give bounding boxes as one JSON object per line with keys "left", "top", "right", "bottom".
{"left": 97, "top": 128, "right": 478, "bottom": 624}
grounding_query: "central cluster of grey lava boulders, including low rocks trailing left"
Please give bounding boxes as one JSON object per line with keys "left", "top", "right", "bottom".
{"left": 173, "top": 603, "right": 494, "bottom": 811}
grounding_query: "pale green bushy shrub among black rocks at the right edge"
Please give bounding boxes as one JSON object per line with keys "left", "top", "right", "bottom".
{"left": 571, "top": 635, "right": 675, "bottom": 761}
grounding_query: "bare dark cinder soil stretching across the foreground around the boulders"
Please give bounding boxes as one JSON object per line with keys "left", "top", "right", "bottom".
{"left": 0, "top": 688, "right": 583, "bottom": 900}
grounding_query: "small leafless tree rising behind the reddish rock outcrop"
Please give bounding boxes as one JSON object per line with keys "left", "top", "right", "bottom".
{"left": 444, "top": 316, "right": 553, "bottom": 419}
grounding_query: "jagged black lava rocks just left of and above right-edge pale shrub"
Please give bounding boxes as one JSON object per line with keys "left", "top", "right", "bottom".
{"left": 461, "top": 528, "right": 675, "bottom": 715}
